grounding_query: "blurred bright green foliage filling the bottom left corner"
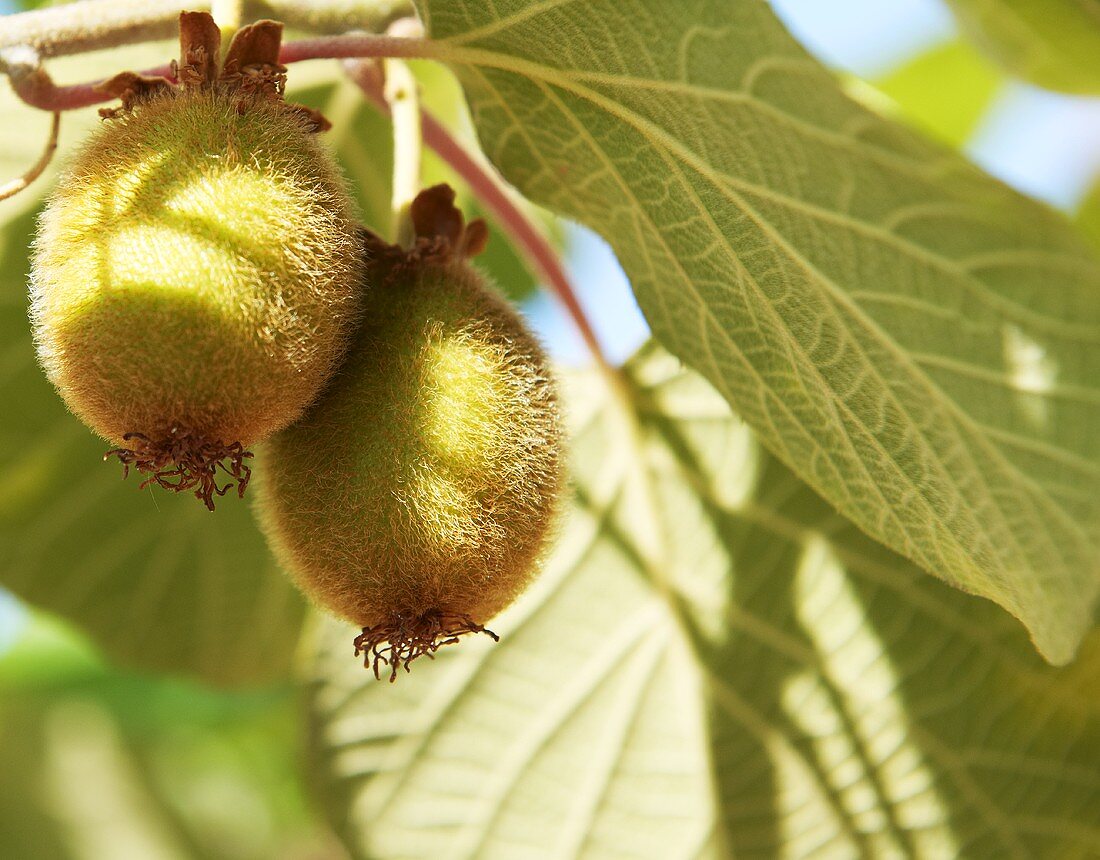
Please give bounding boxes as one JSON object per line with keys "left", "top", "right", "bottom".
{"left": 0, "top": 620, "right": 327, "bottom": 860}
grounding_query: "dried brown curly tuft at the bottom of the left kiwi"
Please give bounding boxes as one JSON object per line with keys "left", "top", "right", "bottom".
{"left": 103, "top": 428, "right": 252, "bottom": 510}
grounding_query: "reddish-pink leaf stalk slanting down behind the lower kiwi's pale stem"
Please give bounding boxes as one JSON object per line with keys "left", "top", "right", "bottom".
{"left": 344, "top": 60, "right": 619, "bottom": 369}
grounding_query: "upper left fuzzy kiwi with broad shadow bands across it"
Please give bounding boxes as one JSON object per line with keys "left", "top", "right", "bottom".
{"left": 31, "top": 13, "right": 363, "bottom": 509}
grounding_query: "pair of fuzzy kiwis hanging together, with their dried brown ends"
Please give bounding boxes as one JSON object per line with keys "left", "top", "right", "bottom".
{"left": 31, "top": 13, "right": 562, "bottom": 680}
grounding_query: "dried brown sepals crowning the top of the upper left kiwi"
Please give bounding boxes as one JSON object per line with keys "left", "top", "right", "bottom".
{"left": 98, "top": 12, "right": 331, "bottom": 132}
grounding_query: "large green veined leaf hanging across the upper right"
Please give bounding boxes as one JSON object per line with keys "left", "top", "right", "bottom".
{"left": 418, "top": 0, "right": 1100, "bottom": 663}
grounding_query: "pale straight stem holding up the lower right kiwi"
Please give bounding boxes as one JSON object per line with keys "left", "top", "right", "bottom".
{"left": 383, "top": 59, "right": 421, "bottom": 247}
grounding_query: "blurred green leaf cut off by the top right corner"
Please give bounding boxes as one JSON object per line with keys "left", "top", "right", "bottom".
{"left": 948, "top": 0, "right": 1100, "bottom": 93}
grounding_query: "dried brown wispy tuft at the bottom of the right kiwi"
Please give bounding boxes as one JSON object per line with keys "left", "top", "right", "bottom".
{"left": 354, "top": 610, "right": 501, "bottom": 684}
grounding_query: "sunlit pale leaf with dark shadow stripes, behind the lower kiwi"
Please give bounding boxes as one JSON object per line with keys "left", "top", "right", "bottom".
{"left": 309, "top": 349, "right": 1100, "bottom": 860}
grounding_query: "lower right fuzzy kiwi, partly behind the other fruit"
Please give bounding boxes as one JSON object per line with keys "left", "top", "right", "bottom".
{"left": 255, "top": 186, "right": 562, "bottom": 681}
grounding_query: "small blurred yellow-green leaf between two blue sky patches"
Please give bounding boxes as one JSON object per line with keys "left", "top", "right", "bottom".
{"left": 875, "top": 42, "right": 1003, "bottom": 146}
